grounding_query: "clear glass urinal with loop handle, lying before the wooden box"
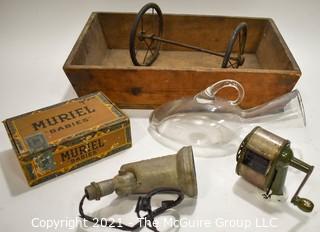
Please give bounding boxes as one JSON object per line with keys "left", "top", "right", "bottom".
{"left": 149, "top": 80, "right": 306, "bottom": 156}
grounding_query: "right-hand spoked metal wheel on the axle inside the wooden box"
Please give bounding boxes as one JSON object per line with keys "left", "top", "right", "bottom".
{"left": 221, "top": 22, "right": 248, "bottom": 68}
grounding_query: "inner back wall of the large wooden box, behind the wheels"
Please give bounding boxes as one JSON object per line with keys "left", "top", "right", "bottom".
{"left": 97, "top": 13, "right": 267, "bottom": 53}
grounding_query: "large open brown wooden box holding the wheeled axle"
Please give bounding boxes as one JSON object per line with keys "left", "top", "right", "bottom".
{"left": 63, "top": 13, "right": 301, "bottom": 108}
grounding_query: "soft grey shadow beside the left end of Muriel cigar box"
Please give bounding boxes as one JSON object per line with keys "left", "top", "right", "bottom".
{"left": 0, "top": 150, "right": 31, "bottom": 196}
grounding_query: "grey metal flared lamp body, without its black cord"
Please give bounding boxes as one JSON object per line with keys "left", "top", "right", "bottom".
{"left": 85, "top": 147, "right": 197, "bottom": 200}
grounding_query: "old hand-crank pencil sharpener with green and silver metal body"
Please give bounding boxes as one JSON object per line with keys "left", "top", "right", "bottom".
{"left": 236, "top": 127, "right": 314, "bottom": 212}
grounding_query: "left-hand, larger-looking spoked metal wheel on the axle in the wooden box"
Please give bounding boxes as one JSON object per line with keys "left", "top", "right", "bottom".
{"left": 129, "top": 3, "right": 163, "bottom": 66}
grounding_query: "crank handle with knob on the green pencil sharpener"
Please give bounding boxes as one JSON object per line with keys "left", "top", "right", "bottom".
{"left": 289, "top": 157, "right": 314, "bottom": 212}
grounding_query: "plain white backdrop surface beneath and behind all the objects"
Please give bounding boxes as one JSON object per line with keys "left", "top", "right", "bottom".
{"left": 0, "top": 0, "right": 320, "bottom": 232}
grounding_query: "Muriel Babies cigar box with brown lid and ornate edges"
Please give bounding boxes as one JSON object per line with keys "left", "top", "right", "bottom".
{"left": 3, "top": 92, "right": 131, "bottom": 186}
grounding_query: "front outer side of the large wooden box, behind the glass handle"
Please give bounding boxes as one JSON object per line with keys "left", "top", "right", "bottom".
{"left": 65, "top": 68, "right": 299, "bottom": 108}
